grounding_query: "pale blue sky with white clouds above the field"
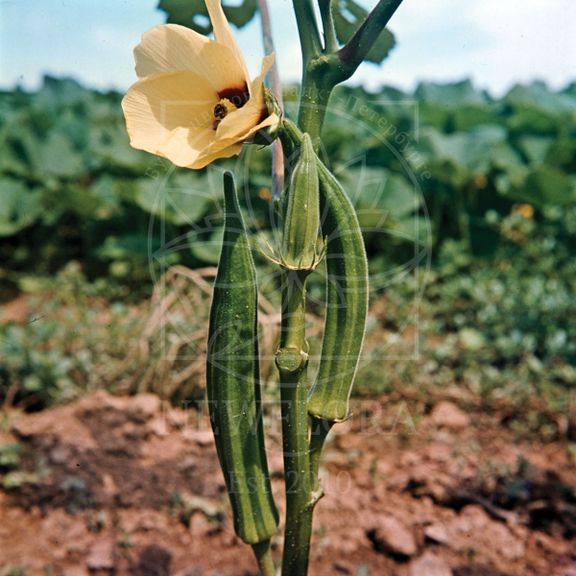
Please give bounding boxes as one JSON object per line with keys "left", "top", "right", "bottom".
{"left": 0, "top": 0, "right": 576, "bottom": 94}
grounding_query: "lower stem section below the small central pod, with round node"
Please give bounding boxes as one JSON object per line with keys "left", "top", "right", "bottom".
{"left": 276, "top": 271, "right": 314, "bottom": 576}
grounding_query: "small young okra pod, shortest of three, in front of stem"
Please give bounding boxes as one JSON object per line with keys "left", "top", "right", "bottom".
{"left": 281, "top": 134, "right": 320, "bottom": 270}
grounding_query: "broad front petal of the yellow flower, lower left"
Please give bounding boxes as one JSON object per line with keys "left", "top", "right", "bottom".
{"left": 122, "top": 71, "right": 218, "bottom": 166}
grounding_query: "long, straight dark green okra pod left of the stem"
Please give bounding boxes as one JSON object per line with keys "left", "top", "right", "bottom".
{"left": 206, "top": 172, "right": 278, "bottom": 545}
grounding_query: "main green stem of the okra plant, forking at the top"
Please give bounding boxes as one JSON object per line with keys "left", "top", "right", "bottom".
{"left": 276, "top": 0, "right": 402, "bottom": 576}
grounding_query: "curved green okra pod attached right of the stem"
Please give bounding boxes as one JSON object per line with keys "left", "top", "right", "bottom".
{"left": 308, "top": 160, "right": 368, "bottom": 422}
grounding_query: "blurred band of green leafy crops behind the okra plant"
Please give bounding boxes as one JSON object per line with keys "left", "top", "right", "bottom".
{"left": 0, "top": 77, "right": 576, "bottom": 436}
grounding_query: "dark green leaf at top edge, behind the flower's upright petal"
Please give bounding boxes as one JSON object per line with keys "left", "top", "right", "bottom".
{"left": 158, "top": 0, "right": 258, "bottom": 34}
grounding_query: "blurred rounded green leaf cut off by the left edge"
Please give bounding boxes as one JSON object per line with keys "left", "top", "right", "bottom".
{"left": 0, "top": 178, "right": 42, "bottom": 236}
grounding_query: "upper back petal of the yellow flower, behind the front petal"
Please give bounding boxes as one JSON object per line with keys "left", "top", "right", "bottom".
{"left": 134, "top": 24, "right": 248, "bottom": 92}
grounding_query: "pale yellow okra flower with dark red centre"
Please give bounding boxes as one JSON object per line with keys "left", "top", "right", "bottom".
{"left": 122, "top": 0, "right": 279, "bottom": 169}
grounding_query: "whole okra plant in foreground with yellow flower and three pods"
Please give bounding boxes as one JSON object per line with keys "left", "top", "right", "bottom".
{"left": 122, "top": 0, "right": 402, "bottom": 576}
